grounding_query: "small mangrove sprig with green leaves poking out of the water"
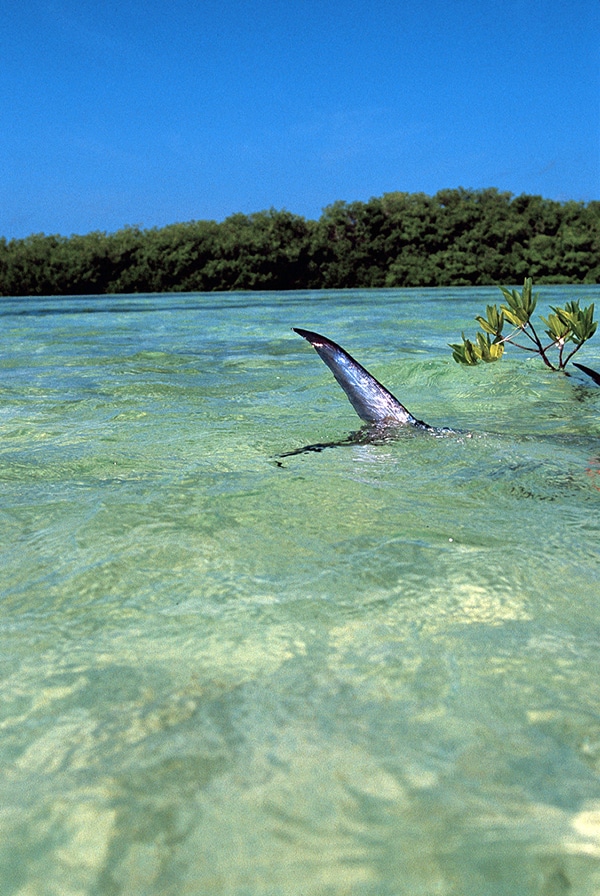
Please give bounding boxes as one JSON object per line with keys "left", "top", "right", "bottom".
{"left": 450, "top": 277, "right": 598, "bottom": 370}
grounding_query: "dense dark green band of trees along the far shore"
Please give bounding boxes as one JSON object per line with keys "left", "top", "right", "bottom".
{"left": 0, "top": 187, "right": 600, "bottom": 296}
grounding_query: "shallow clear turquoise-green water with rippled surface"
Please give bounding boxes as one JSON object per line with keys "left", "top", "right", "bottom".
{"left": 0, "top": 287, "right": 600, "bottom": 896}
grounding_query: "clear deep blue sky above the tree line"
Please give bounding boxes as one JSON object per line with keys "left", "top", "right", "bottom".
{"left": 0, "top": 0, "right": 600, "bottom": 238}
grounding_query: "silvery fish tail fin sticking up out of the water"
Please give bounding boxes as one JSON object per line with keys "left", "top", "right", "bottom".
{"left": 292, "top": 327, "right": 438, "bottom": 432}
